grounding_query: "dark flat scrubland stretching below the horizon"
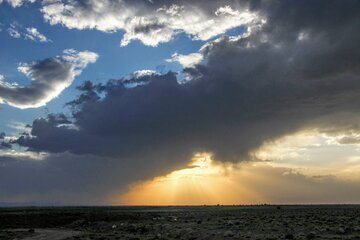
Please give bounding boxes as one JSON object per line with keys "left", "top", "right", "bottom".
{"left": 0, "top": 205, "right": 360, "bottom": 240}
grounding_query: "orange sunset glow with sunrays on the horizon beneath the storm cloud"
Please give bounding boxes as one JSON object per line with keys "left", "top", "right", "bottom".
{"left": 113, "top": 153, "right": 260, "bottom": 205}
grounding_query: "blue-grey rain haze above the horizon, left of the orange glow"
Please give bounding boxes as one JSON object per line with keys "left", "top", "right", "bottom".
{"left": 0, "top": 153, "right": 190, "bottom": 205}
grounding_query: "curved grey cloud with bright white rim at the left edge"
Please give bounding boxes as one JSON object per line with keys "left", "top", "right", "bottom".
{"left": 0, "top": 49, "right": 98, "bottom": 109}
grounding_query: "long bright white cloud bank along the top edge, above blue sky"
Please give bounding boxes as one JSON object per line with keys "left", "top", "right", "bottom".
{"left": 41, "top": 0, "right": 262, "bottom": 46}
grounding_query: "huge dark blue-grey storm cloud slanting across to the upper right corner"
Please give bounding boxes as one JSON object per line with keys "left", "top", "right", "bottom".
{"left": 0, "top": 0, "right": 360, "bottom": 203}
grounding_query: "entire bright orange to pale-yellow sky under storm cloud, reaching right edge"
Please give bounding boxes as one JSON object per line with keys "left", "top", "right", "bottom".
{"left": 108, "top": 131, "right": 360, "bottom": 205}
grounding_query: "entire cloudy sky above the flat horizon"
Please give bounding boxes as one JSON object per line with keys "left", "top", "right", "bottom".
{"left": 0, "top": 0, "right": 360, "bottom": 205}
